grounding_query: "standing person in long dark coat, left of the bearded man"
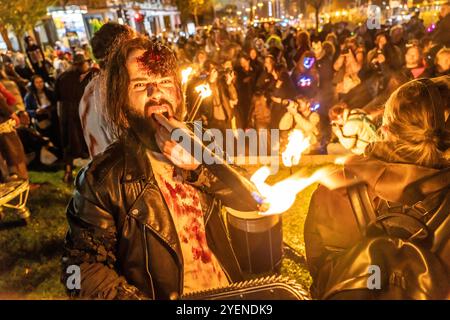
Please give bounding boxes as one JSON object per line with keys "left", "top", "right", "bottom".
{"left": 55, "top": 53, "right": 98, "bottom": 183}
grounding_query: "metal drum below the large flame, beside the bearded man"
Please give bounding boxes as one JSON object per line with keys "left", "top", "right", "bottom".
{"left": 226, "top": 208, "right": 283, "bottom": 273}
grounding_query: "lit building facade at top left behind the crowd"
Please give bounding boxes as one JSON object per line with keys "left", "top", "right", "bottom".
{"left": 0, "top": 0, "right": 181, "bottom": 50}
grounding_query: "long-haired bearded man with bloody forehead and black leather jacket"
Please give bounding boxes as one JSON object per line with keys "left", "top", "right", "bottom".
{"left": 63, "top": 38, "right": 253, "bottom": 299}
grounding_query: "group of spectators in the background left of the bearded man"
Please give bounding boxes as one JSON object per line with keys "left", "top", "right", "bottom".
{"left": 0, "top": 36, "right": 98, "bottom": 182}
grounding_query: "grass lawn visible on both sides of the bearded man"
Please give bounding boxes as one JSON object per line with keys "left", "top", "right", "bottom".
{"left": 0, "top": 169, "right": 324, "bottom": 299}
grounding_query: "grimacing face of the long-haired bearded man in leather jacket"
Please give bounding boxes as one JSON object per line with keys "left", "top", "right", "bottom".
{"left": 126, "top": 49, "right": 181, "bottom": 128}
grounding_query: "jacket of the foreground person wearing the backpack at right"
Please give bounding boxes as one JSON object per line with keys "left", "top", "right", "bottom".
{"left": 304, "top": 156, "right": 450, "bottom": 280}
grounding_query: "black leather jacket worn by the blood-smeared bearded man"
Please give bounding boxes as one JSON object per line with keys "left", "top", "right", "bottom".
{"left": 62, "top": 131, "right": 248, "bottom": 299}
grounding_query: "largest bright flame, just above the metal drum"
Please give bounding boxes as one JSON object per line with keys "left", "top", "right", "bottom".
{"left": 250, "top": 166, "right": 329, "bottom": 215}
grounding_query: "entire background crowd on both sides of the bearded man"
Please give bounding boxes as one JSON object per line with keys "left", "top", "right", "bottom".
{"left": 0, "top": 5, "right": 450, "bottom": 183}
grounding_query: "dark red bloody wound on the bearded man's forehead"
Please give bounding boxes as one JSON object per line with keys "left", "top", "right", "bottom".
{"left": 136, "top": 45, "right": 177, "bottom": 76}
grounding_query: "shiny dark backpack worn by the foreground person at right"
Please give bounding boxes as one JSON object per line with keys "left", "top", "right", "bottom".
{"left": 312, "top": 178, "right": 450, "bottom": 300}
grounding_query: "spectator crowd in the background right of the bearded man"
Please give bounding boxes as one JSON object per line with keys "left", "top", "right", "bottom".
{"left": 174, "top": 5, "right": 450, "bottom": 158}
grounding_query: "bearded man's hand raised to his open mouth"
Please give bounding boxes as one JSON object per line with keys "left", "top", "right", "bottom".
{"left": 154, "top": 114, "right": 200, "bottom": 170}
